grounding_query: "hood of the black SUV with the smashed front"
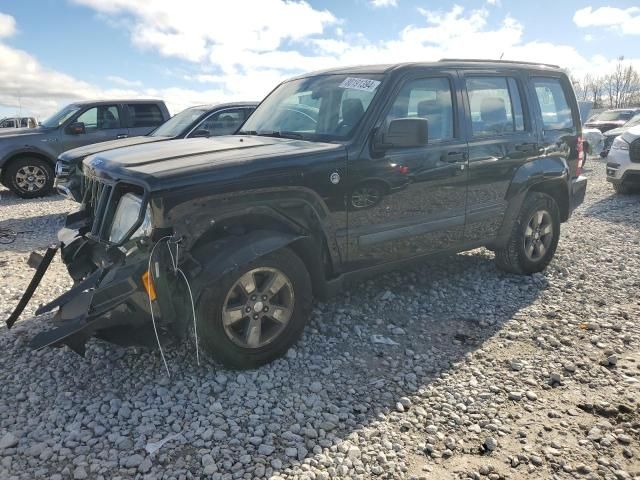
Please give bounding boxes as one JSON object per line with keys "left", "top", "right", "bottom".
{"left": 83, "top": 135, "right": 345, "bottom": 191}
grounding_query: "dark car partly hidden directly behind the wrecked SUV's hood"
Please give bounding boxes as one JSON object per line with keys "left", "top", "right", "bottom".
{"left": 55, "top": 102, "right": 258, "bottom": 202}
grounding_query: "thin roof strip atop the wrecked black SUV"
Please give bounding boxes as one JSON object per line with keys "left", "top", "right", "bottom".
{"left": 294, "top": 58, "right": 562, "bottom": 79}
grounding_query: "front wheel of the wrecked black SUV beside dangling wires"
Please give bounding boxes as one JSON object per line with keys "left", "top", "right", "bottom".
{"left": 198, "top": 248, "right": 313, "bottom": 369}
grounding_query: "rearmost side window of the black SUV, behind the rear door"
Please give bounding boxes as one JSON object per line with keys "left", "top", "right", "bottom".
{"left": 531, "top": 77, "right": 574, "bottom": 130}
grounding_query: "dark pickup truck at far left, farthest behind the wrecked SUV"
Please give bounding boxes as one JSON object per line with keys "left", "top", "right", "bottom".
{"left": 0, "top": 100, "right": 169, "bottom": 198}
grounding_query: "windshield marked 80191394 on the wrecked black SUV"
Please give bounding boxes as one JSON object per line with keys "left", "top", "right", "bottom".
{"left": 238, "top": 74, "right": 382, "bottom": 141}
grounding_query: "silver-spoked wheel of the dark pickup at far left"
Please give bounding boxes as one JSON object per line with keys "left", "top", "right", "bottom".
{"left": 4, "top": 157, "right": 55, "bottom": 198}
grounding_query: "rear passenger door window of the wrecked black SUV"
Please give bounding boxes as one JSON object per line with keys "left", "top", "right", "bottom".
{"left": 466, "top": 76, "right": 525, "bottom": 137}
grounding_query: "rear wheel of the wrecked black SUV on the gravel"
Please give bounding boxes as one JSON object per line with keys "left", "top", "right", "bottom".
{"left": 496, "top": 192, "right": 560, "bottom": 275}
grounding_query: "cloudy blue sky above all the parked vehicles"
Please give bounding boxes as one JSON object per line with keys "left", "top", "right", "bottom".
{"left": 0, "top": 0, "right": 640, "bottom": 120}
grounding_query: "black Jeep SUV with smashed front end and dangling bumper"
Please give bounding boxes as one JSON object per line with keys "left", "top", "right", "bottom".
{"left": 9, "top": 60, "right": 586, "bottom": 368}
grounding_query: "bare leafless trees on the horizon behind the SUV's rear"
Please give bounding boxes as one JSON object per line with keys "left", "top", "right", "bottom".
{"left": 571, "top": 57, "right": 640, "bottom": 109}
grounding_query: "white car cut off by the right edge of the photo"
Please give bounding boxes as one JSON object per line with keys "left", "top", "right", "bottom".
{"left": 607, "top": 126, "right": 640, "bottom": 193}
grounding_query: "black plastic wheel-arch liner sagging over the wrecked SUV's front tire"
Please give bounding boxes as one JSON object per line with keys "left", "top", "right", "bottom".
{"left": 190, "top": 230, "right": 309, "bottom": 301}
